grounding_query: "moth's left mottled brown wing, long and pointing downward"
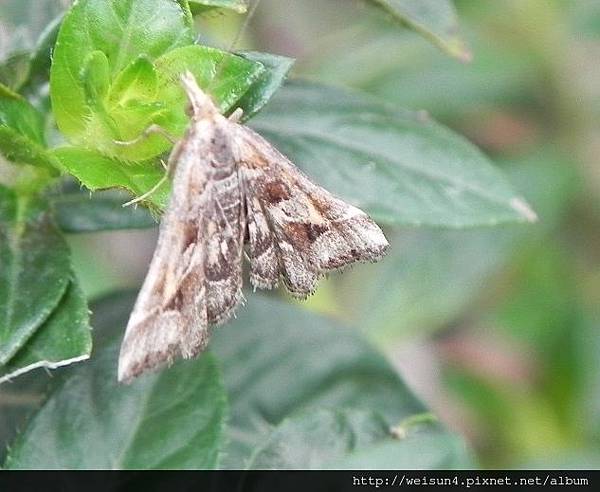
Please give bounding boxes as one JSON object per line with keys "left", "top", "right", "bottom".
{"left": 119, "top": 117, "right": 245, "bottom": 381}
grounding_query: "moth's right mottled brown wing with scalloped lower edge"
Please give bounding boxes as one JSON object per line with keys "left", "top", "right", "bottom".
{"left": 236, "top": 126, "right": 388, "bottom": 297}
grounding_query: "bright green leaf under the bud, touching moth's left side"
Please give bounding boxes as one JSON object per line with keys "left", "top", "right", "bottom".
{"left": 53, "top": 147, "right": 169, "bottom": 208}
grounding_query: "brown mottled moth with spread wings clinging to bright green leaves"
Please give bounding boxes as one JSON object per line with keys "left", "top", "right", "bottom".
{"left": 118, "top": 72, "right": 388, "bottom": 382}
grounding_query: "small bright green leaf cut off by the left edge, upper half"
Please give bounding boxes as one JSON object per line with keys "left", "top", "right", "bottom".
{"left": 0, "top": 85, "right": 56, "bottom": 174}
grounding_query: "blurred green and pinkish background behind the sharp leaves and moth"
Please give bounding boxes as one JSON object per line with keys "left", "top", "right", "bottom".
{"left": 0, "top": 0, "right": 600, "bottom": 468}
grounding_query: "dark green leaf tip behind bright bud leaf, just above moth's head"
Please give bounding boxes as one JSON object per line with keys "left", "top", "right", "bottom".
{"left": 236, "top": 51, "right": 295, "bottom": 121}
